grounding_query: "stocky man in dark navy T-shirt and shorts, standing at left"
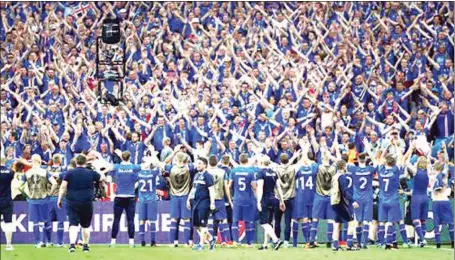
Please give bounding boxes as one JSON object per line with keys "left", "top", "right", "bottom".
{"left": 58, "top": 154, "right": 105, "bottom": 252}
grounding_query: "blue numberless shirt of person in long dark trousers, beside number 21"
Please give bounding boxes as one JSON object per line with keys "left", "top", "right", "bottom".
{"left": 112, "top": 164, "right": 141, "bottom": 197}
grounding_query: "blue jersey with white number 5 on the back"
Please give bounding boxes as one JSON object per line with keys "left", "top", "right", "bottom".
{"left": 231, "top": 166, "right": 257, "bottom": 205}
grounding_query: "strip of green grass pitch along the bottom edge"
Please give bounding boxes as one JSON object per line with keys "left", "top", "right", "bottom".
{"left": 0, "top": 245, "right": 454, "bottom": 260}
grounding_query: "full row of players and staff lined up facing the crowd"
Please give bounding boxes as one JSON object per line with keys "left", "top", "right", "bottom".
{"left": 0, "top": 137, "right": 454, "bottom": 252}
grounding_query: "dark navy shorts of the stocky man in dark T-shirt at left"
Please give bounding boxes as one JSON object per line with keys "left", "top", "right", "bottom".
{"left": 66, "top": 201, "right": 93, "bottom": 228}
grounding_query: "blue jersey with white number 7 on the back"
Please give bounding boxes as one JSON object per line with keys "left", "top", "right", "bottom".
{"left": 378, "top": 166, "right": 402, "bottom": 203}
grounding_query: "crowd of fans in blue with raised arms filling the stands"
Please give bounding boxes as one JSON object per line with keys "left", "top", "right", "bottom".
{"left": 0, "top": 2, "right": 454, "bottom": 197}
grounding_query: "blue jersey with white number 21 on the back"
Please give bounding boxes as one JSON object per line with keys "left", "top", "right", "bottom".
{"left": 137, "top": 168, "right": 161, "bottom": 202}
